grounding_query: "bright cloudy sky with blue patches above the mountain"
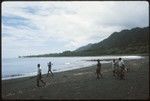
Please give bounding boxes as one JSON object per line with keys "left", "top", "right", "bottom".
{"left": 1, "top": 1, "right": 149, "bottom": 58}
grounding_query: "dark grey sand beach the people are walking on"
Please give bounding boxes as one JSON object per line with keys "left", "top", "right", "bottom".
{"left": 2, "top": 56, "right": 149, "bottom": 99}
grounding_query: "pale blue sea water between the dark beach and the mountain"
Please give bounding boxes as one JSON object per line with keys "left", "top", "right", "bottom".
{"left": 2, "top": 56, "right": 143, "bottom": 80}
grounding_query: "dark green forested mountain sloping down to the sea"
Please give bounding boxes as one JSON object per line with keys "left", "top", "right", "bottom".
{"left": 24, "top": 27, "right": 149, "bottom": 57}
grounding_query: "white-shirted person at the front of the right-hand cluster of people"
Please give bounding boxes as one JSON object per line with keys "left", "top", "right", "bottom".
{"left": 118, "top": 58, "right": 127, "bottom": 80}
